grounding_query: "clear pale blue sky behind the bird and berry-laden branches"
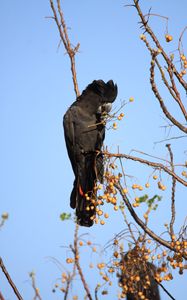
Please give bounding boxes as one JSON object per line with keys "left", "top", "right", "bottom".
{"left": 0, "top": 0, "right": 187, "bottom": 300}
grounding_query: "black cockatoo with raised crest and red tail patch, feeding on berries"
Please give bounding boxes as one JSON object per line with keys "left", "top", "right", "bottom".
{"left": 63, "top": 80, "right": 117, "bottom": 226}
